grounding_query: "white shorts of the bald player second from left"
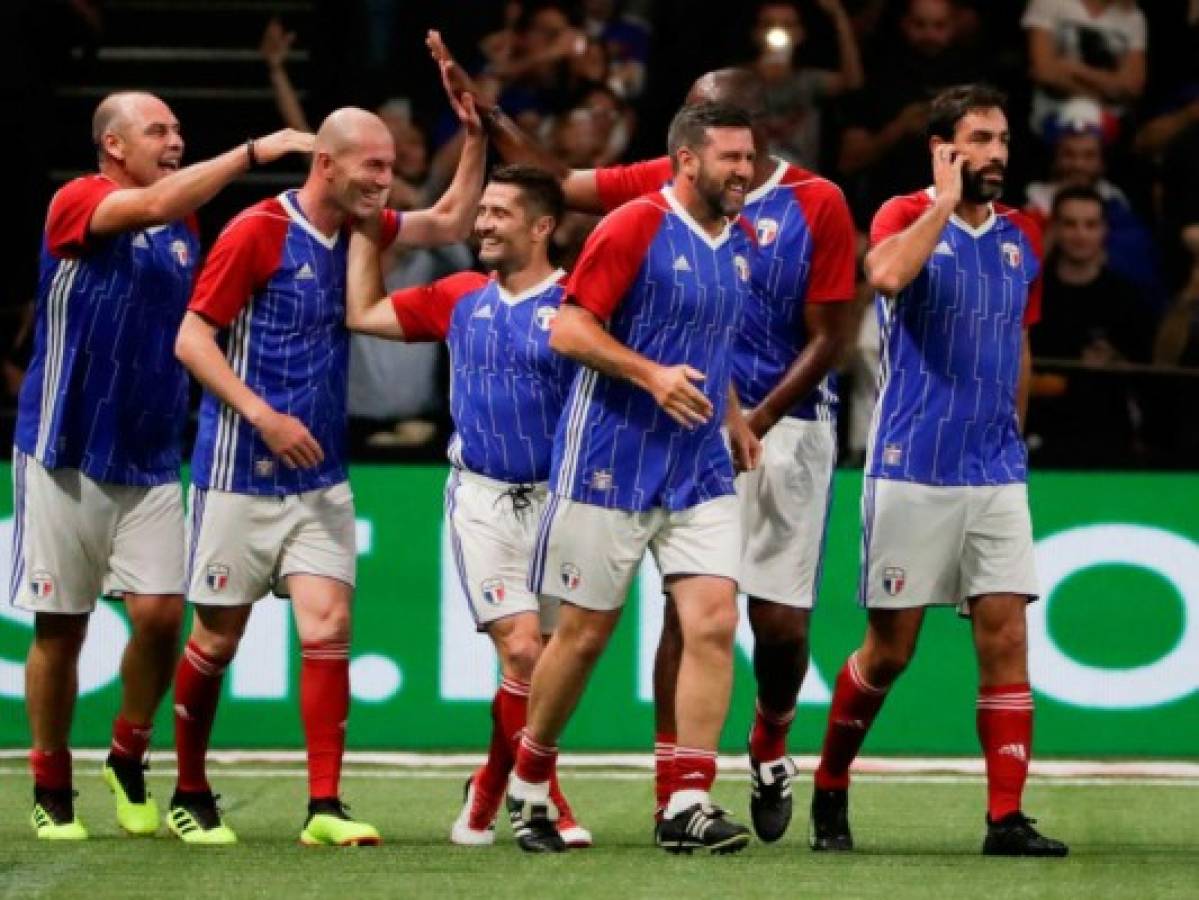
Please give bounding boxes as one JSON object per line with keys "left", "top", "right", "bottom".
{"left": 188, "top": 482, "right": 357, "bottom": 606}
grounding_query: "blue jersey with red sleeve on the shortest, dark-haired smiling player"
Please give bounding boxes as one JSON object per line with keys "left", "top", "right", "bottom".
{"left": 391, "top": 271, "right": 576, "bottom": 484}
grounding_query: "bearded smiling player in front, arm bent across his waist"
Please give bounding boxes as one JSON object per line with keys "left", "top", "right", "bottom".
{"left": 508, "top": 103, "right": 759, "bottom": 852}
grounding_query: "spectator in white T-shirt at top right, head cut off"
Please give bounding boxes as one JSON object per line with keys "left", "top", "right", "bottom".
{"left": 1022, "top": 0, "right": 1146, "bottom": 139}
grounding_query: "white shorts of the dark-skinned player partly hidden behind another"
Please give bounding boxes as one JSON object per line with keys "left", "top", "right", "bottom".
{"left": 737, "top": 418, "right": 837, "bottom": 609}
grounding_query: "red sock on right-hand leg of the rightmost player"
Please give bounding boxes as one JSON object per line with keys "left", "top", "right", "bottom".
{"left": 978, "top": 683, "right": 1032, "bottom": 822}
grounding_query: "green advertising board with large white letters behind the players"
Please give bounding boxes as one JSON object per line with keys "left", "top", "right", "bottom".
{"left": 0, "top": 465, "right": 1199, "bottom": 757}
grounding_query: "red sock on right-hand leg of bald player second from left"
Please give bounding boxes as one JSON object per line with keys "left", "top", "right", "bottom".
{"left": 300, "top": 641, "right": 350, "bottom": 799}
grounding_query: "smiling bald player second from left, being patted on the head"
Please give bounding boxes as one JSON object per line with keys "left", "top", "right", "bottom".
{"left": 168, "top": 101, "right": 486, "bottom": 846}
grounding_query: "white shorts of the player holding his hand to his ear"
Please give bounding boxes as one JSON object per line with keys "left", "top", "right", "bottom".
{"left": 858, "top": 478, "right": 1040, "bottom": 615}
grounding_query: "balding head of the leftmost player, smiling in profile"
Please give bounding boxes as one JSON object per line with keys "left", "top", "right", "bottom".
{"left": 100, "top": 93, "right": 183, "bottom": 187}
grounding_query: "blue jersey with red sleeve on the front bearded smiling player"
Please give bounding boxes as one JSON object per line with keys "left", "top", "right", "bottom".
{"left": 550, "top": 188, "right": 753, "bottom": 511}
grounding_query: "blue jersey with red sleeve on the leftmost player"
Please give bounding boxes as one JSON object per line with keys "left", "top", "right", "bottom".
{"left": 16, "top": 175, "right": 200, "bottom": 485}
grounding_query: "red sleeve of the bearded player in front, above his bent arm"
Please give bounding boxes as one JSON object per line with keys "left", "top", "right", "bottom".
{"left": 566, "top": 198, "right": 665, "bottom": 322}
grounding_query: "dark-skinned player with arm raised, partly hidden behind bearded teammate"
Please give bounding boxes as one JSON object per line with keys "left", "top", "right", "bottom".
{"left": 429, "top": 34, "right": 855, "bottom": 841}
